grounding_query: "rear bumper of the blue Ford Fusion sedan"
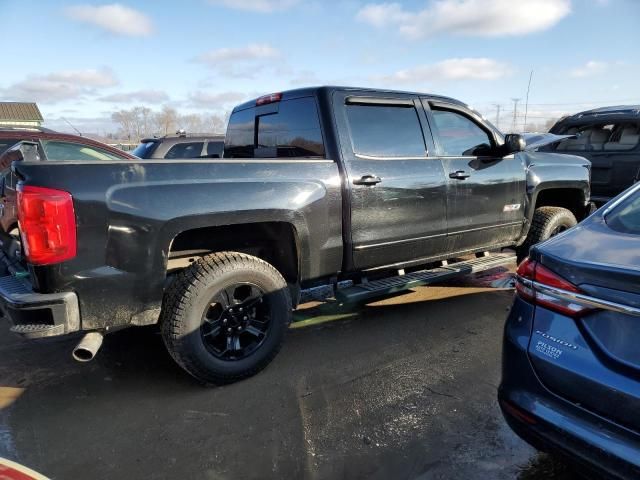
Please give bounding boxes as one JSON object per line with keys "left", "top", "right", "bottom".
{"left": 498, "top": 297, "right": 640, "bottom": 479}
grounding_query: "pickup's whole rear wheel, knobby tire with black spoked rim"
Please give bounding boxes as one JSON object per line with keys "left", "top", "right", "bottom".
{"left": 161, "top": 252, "right": 292, "bottom": 384}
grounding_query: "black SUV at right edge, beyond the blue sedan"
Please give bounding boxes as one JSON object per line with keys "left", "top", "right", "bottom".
{"left": 541, "top": 105, "right": 640, "bottom": 204}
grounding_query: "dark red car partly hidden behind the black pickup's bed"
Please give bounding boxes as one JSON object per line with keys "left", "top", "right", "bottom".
{"left": 0, "top": 127, "right": 136, "bottom": 232}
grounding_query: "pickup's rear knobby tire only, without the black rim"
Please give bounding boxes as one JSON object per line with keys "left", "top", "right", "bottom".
{"left": 160, "top": 252, "right": 292, "bottom": 385}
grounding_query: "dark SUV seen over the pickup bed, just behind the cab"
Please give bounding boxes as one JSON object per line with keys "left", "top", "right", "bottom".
{"left": 131, "top": 133, "right": 224, "bottom": 160}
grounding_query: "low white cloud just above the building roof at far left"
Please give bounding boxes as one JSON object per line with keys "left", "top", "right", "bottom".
{"left": 0, "top": 68, "right": 119, "bottom": 104}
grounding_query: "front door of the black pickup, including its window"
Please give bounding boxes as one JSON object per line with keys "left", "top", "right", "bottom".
{"left": 423, "top": 99, "right": 526, "bottom": 253}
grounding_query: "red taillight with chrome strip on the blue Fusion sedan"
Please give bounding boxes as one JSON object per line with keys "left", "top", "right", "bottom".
{"left": 516, "top": 258, "right": 588, "bottom": 316}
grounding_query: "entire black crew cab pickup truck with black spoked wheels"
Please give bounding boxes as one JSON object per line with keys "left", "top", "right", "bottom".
{"left": 0, "top": 87, "right": 590, "bottom": 383}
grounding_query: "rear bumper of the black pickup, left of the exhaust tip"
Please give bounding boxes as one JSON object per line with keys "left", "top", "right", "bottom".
{"left": 0, "top": 275, "right": 80, "bottom": 338}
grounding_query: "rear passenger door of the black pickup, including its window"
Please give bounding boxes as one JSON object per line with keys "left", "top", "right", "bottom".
{"left": 333, "top": 91, "right": 446, "bottom": 270}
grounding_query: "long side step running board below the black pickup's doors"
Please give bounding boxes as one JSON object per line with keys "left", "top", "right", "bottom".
{"left": 336, "top": 253, "right": 516, "bottom": 303}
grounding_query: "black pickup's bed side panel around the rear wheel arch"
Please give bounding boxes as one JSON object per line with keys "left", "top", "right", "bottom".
{"left": 14, "top": 159, "right": 342, "bottom": 329}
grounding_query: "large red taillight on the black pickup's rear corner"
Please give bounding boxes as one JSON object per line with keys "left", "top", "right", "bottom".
{"left": 17, "top": 185, "right": 76, "bottom": 265}
